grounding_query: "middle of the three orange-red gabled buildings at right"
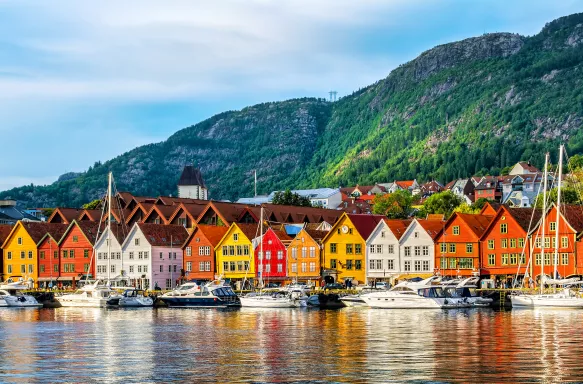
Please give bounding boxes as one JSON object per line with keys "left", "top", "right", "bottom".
{"left": 480, "top": 205, "right": 542, "bottom": 280}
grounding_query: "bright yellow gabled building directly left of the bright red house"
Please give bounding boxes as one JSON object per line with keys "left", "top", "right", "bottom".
{"left": 215, "top": 223, "right": 259, "bottom": 281}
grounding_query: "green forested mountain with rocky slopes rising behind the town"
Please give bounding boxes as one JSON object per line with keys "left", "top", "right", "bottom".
{"left": 0, "top": 14, "right": 583, "bottom": 206}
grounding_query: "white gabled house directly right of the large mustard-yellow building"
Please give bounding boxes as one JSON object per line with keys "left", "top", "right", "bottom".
{"left": 366, "top": 219, "right": 411, "bottom": 284}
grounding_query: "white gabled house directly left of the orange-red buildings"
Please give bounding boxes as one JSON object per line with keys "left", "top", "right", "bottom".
{"left": 399, "top": 219, "right": 444, "bottom": 279}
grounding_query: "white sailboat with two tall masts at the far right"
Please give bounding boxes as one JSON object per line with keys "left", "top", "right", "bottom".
{"left": 510, "top": 145, "right": 583, "bottom": 308}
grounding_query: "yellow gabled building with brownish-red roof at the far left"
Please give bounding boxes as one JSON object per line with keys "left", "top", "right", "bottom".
{"left": 2, "top": 221, "right": 67, "bottom": 287}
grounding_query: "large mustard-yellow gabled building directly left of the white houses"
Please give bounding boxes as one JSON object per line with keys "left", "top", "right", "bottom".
{"left": 322, "top": 213, "right": 385, "bottom": 284}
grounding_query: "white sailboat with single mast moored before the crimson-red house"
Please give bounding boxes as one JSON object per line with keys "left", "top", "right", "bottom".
{"left": 240, "top": 207, "right": 307, "bottom": 308}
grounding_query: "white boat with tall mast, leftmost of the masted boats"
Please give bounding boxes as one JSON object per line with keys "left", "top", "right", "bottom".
{"left": 55, "top": 172, "right": 118, "bottom": 307}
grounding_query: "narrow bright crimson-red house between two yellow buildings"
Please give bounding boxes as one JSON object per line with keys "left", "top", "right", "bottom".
{"left": 255, "top": 228, "right": 292, "bottom": 283}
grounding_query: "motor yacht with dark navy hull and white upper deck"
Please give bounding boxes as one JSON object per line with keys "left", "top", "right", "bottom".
{"left": 160, "top": 281, "right": 241, "bottom": 308}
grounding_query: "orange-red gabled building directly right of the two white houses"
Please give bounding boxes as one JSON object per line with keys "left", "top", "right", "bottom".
{"left": 435, "top": 212, "right": 493, "bottom": 277}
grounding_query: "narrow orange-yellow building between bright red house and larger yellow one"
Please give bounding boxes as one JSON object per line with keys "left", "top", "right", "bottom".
{"left": 287, "top": 228, "right": 328, "bottom": 286}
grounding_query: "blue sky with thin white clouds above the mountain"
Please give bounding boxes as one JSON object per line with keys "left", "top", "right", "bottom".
{"left": 0, "top": 0, "right": 583, "bottom": 191}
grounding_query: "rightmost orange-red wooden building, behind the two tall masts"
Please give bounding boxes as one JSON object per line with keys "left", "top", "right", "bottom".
{"left": 531, "top": 204, "right": 583, "bottom": 277}
